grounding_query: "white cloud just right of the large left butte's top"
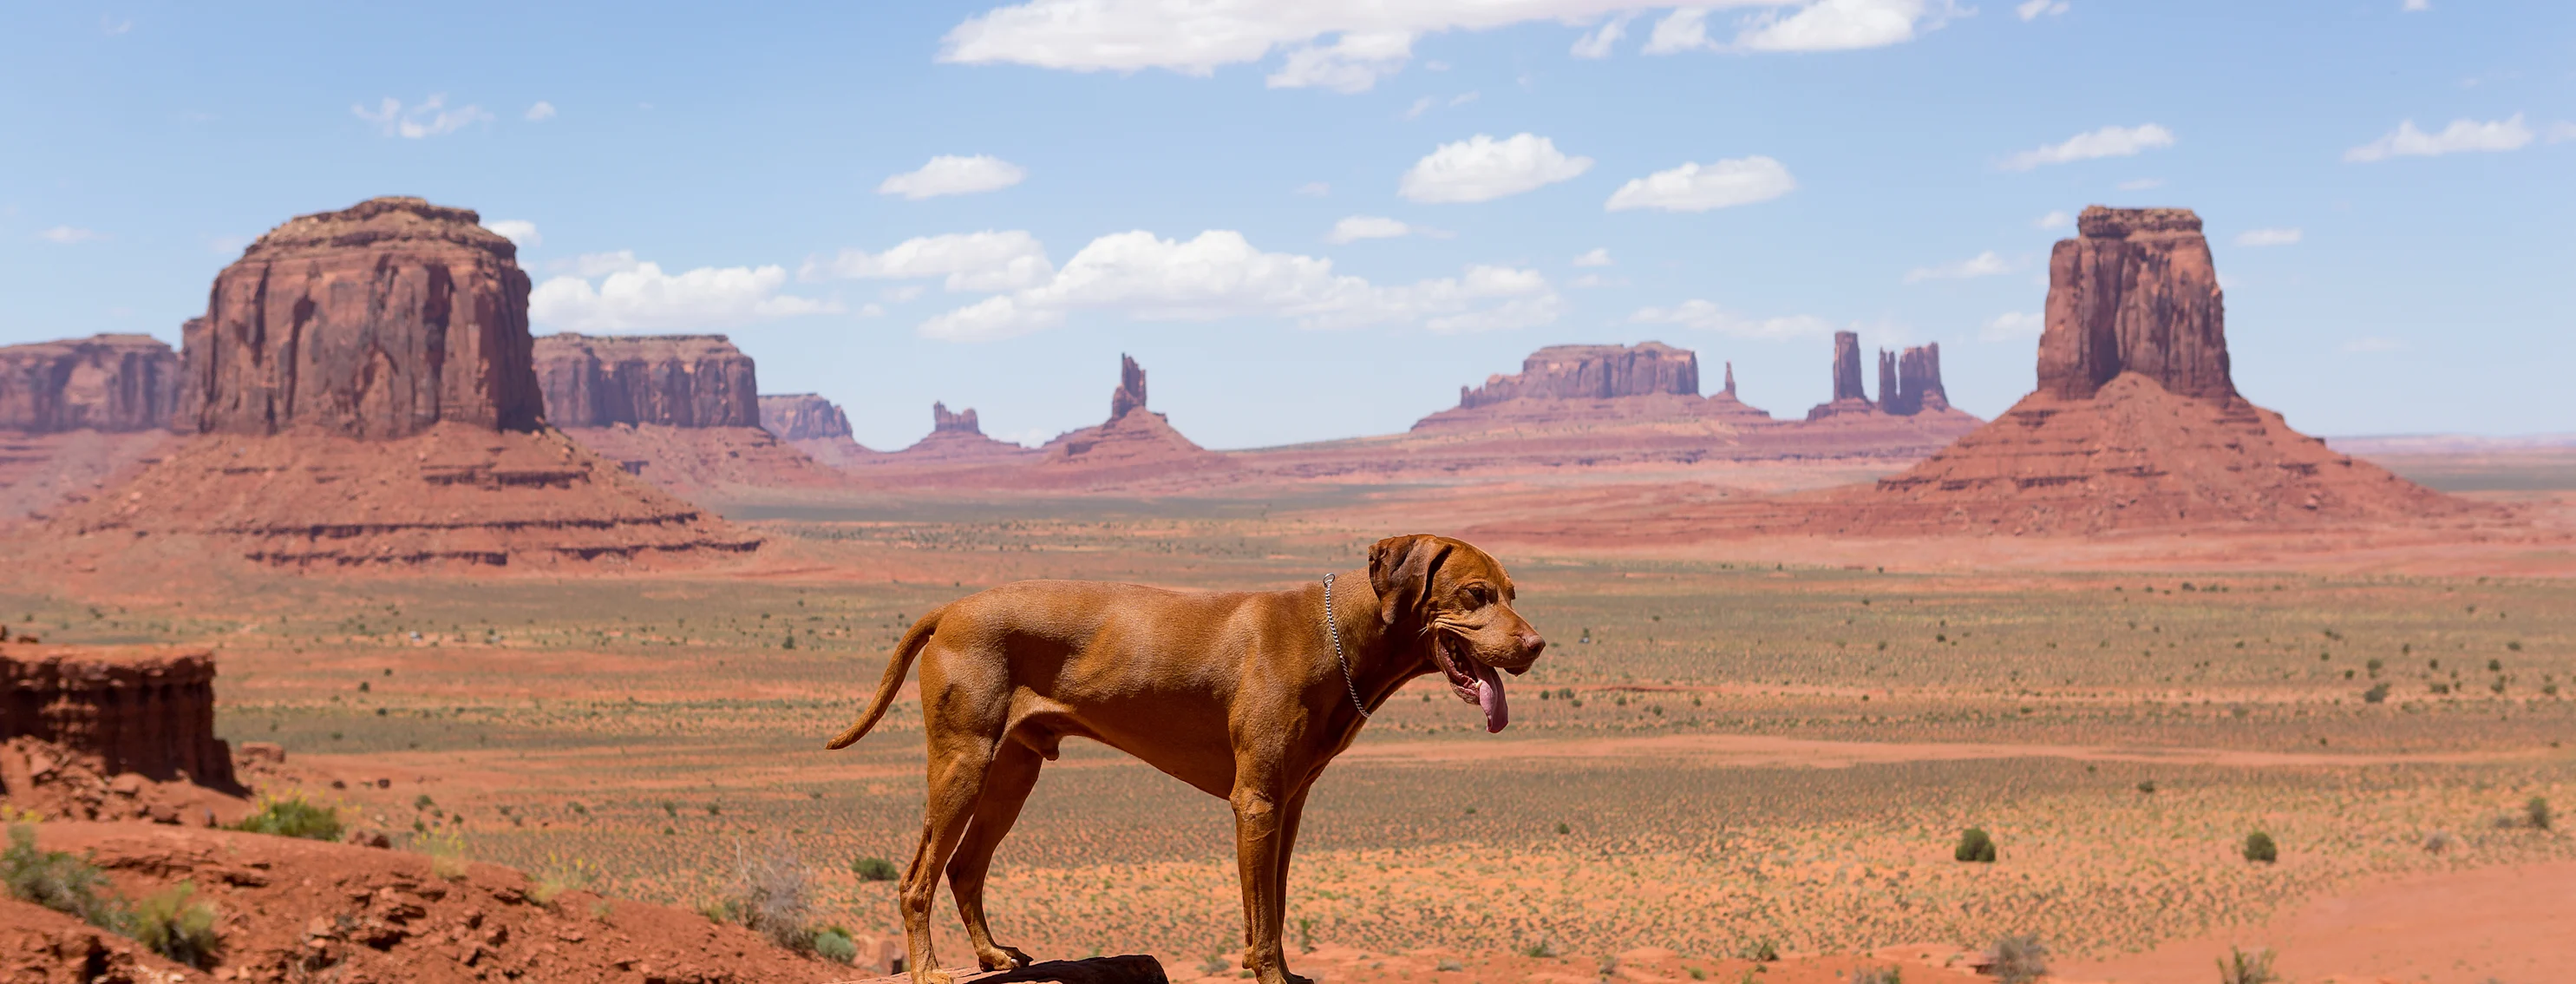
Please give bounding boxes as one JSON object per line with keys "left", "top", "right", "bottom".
{"left": 528, "top": 259, "right": 840, "bottom": 332}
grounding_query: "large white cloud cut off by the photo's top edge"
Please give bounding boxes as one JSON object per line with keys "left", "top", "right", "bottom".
{"left": 938, "top": 0, "right": 1960, "bottom": 93}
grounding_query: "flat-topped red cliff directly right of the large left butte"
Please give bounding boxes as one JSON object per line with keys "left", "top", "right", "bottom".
{"left": 536, "top": 332, "right": 760, "bottom": 428}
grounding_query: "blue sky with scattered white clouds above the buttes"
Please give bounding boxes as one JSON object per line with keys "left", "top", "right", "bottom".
{"left": 0, "top": 0, "right": 2576, "bottom": 449}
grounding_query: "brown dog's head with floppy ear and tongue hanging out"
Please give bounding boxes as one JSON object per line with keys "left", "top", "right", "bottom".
{"left": 1368, "top": 533, "right": 1548, "bottom": 731}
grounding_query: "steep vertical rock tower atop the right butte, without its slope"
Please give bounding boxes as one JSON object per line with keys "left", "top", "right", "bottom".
{"left": 2040, "top": 206, "right": 2236, "bottom": 399}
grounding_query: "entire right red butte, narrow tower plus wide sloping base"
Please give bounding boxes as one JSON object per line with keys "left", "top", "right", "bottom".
{"left": 1844, "top": 206, "right": 2475, "bottom": 533}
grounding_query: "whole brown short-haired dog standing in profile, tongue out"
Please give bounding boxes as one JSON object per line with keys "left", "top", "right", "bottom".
{"left": 827, "top": 533, "right": 1546, "bottom": 984}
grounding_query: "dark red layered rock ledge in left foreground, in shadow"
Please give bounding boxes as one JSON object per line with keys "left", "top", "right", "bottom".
{"left": 0, "top": 644, "right": 234, "bottom": 788}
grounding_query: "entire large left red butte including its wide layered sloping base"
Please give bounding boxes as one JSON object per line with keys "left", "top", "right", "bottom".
{"left": 51, "top": 199, "right": 760, "bottom": 567}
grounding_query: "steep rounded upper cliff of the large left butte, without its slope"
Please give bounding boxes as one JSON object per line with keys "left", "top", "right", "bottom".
{"left": 180, "top": 199, "right": 544, "bottom": 438}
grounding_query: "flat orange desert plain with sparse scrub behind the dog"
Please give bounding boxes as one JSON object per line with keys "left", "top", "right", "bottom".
{"left": 0, "top": 453, "right": 2576, "bottom": 984}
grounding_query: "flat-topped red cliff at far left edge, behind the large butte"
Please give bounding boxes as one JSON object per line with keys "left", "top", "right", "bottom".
{"left": 0, "top": 335, "right": 180, "bottom": 433}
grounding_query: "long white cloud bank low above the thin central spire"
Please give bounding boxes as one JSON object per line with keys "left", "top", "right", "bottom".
{"left": 919, "top": 229, "right": 1564, "bottom": 340}
